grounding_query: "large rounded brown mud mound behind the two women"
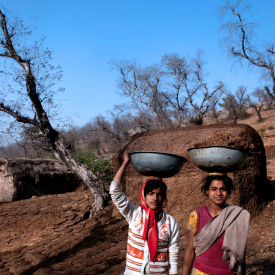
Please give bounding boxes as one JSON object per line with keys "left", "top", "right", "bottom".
{"left": 113, "top": 124, "right": 267, "bottom": 226}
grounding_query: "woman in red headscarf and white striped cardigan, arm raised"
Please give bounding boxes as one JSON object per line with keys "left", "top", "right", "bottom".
{"left": 110, "top": 153, "right": 179, "bottom": 275}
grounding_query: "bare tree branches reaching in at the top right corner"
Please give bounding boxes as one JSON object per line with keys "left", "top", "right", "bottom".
{"left": 220, "top": 0, "right": 275, "bottom": 100}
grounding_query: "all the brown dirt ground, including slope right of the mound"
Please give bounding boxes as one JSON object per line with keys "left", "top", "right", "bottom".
{"left": 0, "top": 110, "right": 275, "bottom": 275}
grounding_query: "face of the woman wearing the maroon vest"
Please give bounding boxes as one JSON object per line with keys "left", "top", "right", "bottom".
{"left": 206, "top": 179, "right": 228, "bottom": 205}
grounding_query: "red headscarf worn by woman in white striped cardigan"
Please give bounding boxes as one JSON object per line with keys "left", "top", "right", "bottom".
{"left": 140, "top": 179, "right": 163, "bottom": 261}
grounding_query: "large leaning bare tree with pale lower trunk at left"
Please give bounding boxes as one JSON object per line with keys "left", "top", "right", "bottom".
{"left": 0, "top": 7, "right": 105, "bottom": 212}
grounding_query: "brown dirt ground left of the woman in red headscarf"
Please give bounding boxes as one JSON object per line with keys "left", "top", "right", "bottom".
{"left": 0, "top": 191, "right": 127, "bottom": 274}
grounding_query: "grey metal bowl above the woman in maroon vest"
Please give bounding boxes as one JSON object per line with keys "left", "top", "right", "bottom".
{"left": 188, "top": 146, "right": 248, "bottom": 173}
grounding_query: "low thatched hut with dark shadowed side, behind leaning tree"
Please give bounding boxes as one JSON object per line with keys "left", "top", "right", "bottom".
{"left": 0, "top": 158, "right": 83, "bottom": 202}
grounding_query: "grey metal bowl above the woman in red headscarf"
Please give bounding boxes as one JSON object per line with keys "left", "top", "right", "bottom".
{"left": 129, "top": 151, "right": 187, "bottom": 178}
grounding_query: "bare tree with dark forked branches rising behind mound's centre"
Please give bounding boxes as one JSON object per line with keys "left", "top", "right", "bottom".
{"left": 162, "top": 51, "right": 224, "bottom": 126}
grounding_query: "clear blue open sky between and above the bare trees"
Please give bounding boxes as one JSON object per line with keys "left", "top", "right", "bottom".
{"left": 0, "top": 0, "right": 275, "bottom": 127}
